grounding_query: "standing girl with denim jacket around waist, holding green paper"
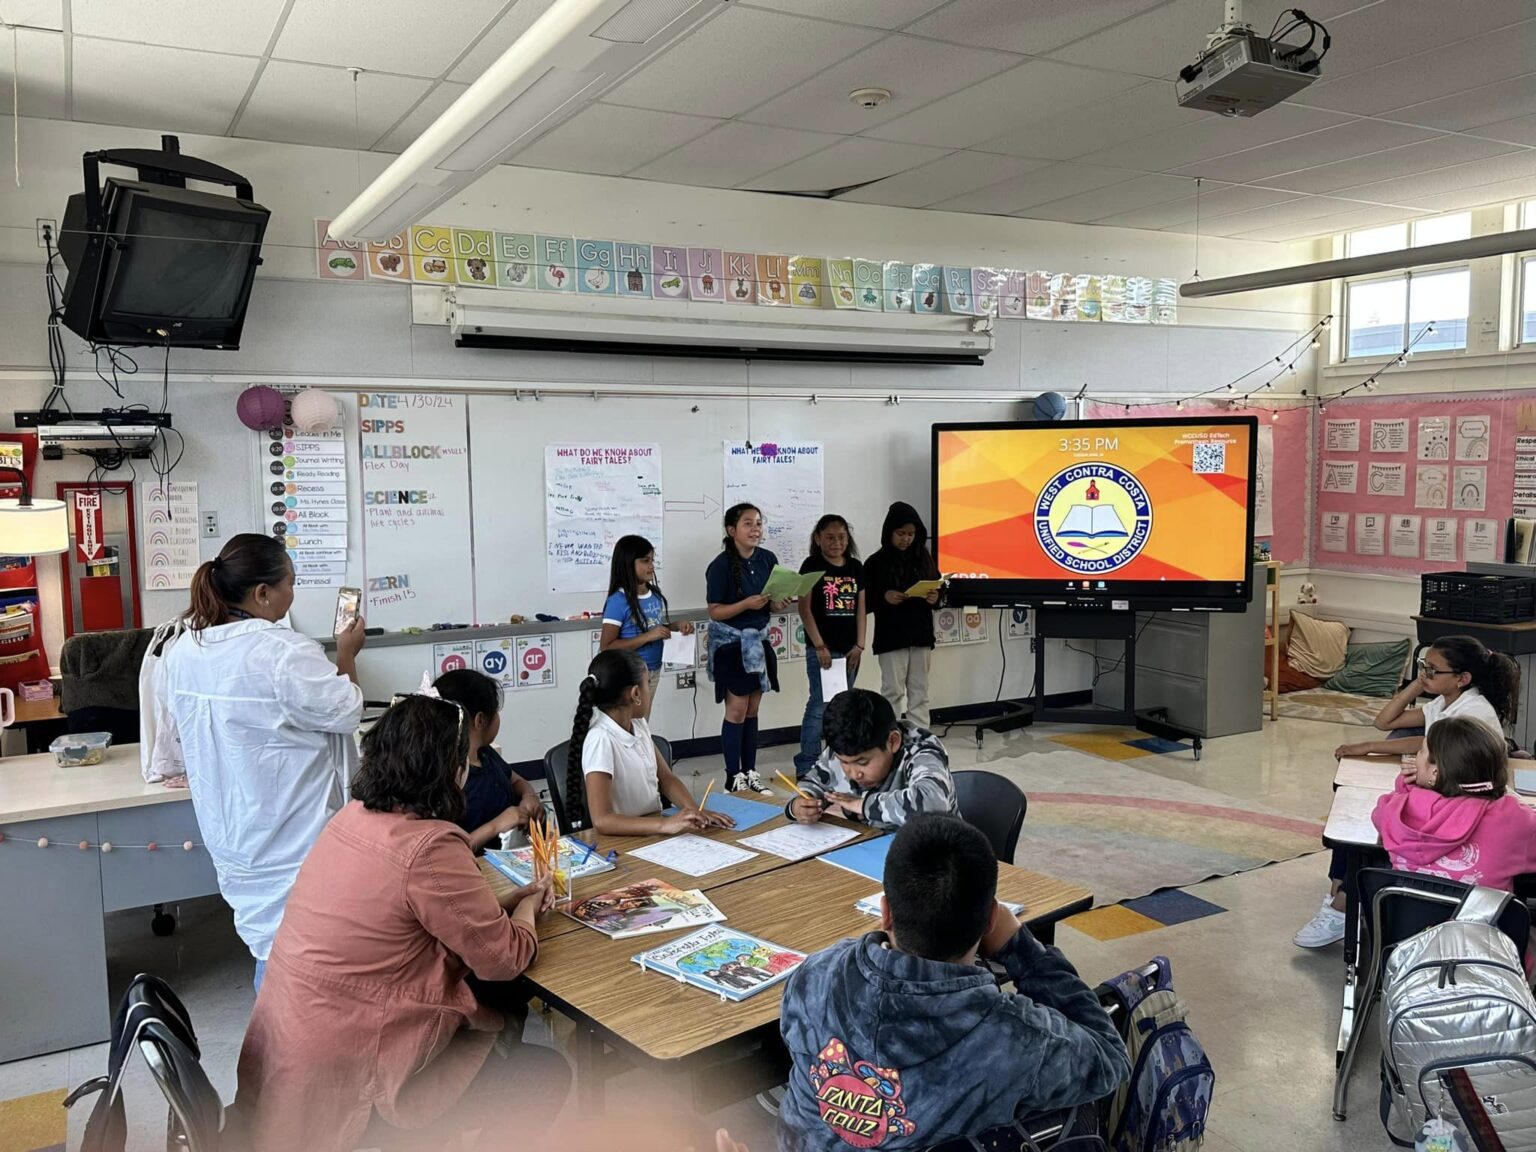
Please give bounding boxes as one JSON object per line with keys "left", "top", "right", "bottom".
{"left": 703, "top": 504, "right": 788, "bottom": 796}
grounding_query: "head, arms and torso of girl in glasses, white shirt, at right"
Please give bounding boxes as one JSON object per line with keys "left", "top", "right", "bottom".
{"left": 1333, "top": 636, "right": 1521, "bottom": 759}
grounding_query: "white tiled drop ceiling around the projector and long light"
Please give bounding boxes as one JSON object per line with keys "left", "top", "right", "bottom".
{"left": 9, "top": 0, "right": 1536, "bottom": 240}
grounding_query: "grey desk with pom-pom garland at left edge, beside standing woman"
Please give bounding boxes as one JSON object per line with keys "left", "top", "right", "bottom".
{"left": 0, "top": 743, "right": 218, "bottom": 1063}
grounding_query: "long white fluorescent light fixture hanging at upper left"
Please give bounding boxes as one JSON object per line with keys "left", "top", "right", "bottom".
{"left": 330, "top": 0, "right": 730, "bottom": 241}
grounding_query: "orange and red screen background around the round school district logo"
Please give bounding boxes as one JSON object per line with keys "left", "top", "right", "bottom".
{"left": 937, "top": 424, "right": 1252, "bottom": 582}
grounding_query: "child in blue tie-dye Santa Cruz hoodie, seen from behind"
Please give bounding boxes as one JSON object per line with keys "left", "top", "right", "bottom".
{"left": 779, "top": 814, "right": 1130, "bottom": 1152}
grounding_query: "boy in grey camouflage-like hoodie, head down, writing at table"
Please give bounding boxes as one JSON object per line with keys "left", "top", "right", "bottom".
{"left": 785, "top": 688, "right": 960, "bottom": 831}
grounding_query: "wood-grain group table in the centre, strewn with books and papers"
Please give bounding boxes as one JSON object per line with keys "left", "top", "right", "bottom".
{"left": 524, "top": 857, "right": 1092, "bottom": 1112}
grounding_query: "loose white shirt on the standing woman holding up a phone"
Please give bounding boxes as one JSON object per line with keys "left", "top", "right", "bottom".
{"left": 163, "top": 621, "right": 362, "bottom": 960}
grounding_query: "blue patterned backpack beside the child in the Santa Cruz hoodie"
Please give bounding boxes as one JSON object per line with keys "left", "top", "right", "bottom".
{"left": 1098, "top": 955, "right": 1217, "bottom": 1152}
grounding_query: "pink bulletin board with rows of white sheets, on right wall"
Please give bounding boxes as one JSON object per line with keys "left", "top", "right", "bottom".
{"left": 1308, "top": 392, "right": 1511, "bottom": 573}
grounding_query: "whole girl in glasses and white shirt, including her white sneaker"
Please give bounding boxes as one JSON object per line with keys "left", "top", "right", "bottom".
{"left": 1292, "top": 636, "right": 1521, "bottom": 948}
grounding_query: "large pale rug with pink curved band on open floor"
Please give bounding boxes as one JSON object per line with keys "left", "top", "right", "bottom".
{"left": 978, "top": 748, "right": 1322, "bottom": 905}
